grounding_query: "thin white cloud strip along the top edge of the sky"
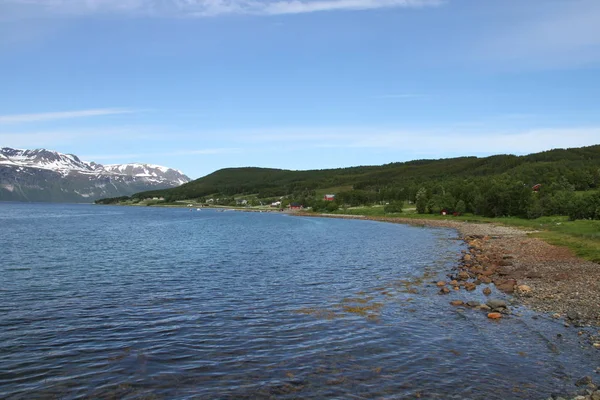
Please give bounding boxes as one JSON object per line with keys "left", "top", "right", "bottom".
{"left": 0, "top": 0, "right": 444, "bottom": 17}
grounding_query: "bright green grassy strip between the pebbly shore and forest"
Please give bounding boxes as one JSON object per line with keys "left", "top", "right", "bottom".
{"left": 326, "top": 206, "right": 600, "bottom": 263}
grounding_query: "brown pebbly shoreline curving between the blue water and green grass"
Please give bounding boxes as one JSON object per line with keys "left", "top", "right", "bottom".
{"left": 295, "top": 213, "right": 600, "bottom": 330}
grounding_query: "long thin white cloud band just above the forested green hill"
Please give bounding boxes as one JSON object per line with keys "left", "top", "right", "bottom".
{"left": 244, "top": 126, "right": 600, "bottom": 157}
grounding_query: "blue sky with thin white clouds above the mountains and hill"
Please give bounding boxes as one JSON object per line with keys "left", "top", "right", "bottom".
{"left": 0, "top": 0, "right": 600, "bottom": 178}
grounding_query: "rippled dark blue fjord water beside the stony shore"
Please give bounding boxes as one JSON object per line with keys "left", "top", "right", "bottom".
{"left": 0, "top": 203, "right": 597, "bottom": 399}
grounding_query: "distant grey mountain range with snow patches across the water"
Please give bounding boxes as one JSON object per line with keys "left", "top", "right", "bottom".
{"left": 0, "top": 147, "right": 190, "bottom": 203}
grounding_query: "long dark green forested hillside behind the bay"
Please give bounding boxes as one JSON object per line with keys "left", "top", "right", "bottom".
{"left": 98, "top": 145, "right": 600, "bottom": 219}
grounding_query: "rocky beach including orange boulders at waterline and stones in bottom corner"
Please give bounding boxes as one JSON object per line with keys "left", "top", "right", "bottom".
{"left": 303, "top": 214, "right": 600, "bottom": 400}
